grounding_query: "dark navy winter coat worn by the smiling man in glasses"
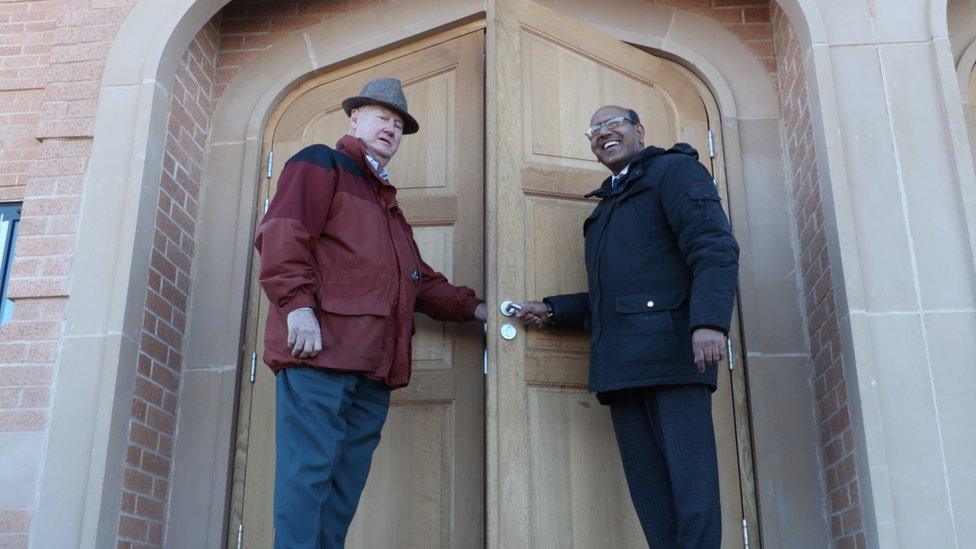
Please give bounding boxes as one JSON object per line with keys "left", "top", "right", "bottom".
{"left": 546, "top": 143, "right": 739, "bottom": 400}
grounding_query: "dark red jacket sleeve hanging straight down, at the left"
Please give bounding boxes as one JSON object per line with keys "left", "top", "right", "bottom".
{"left": 254, "top": 156, "right": 335, "bottom": 312}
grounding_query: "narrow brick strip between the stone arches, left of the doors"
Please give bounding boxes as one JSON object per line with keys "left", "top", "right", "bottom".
{"left": 118, "top": 15, "right": 219, "bottom": 548}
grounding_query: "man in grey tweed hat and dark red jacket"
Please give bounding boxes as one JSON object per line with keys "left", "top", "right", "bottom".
{"left": 255, "top": 78, "right": 486, "bottom": 549}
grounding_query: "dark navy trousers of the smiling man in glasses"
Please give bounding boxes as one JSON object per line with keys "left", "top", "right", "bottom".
{"left": 605, "top": 385, "right": 722, "bottom": 549}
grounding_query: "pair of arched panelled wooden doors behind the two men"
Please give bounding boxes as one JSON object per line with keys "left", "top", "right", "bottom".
{"left": 228, "top": 6, "right": 758, "bottom": 549}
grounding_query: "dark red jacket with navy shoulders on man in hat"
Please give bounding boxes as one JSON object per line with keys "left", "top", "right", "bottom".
{"left": 255, "top": 136, "right": 481, "bottom": 388}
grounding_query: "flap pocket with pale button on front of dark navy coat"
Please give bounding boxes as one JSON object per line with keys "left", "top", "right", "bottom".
{"left": 614, "top": 290, "right": 688, "bottom": 364}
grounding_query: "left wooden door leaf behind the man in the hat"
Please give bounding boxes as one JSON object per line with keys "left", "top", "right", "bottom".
{"left": 228, "top": 22, "right": 484, "bottom": 548}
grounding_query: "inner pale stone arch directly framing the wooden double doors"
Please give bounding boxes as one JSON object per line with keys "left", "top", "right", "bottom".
{"left": 167, "top": 2, "right": 823, "bottom": 539}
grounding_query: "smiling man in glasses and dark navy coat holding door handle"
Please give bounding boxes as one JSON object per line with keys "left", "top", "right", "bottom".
{"left": 518, "top": 105, "right": 739, "bottom": 549}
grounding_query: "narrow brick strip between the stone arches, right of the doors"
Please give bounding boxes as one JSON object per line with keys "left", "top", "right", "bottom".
{"left": 772, "top": 6, "right": 866, "bottom": 548}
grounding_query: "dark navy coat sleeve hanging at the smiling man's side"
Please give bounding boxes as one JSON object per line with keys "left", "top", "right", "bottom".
{"left": 660, "top": 155, "right": 739, "bottom": 333}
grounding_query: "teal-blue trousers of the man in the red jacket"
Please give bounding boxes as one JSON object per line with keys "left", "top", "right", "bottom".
{"left": 274, "top": 367, "right": 390, "bottom": 549}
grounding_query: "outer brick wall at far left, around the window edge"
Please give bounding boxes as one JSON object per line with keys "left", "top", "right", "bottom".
{"left": 0, "top": 0, "right": 142, "bottom": 547}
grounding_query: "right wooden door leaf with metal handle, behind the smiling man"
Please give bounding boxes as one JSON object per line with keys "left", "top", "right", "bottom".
{"left": 487, "top": 0, "right": 757, "bottom": 548}
